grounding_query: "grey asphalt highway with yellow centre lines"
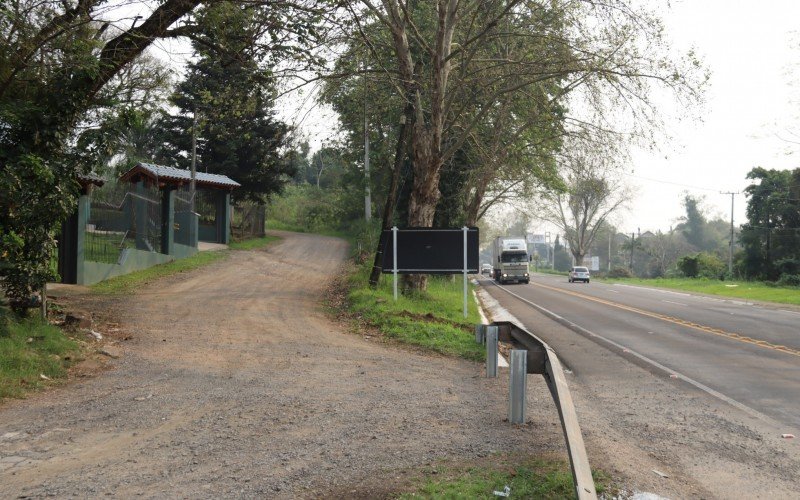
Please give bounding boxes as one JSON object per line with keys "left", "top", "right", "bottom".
{"left": 483, "top": 275, "right": 800, "bottom": 434}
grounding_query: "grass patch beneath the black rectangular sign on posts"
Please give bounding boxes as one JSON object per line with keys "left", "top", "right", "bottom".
{"left": 348, "top": 261, "right": 485, "bottom": 361}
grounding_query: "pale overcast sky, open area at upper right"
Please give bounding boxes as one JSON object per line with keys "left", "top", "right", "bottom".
{"left": 620, "top": 0, "right": 800, "bottom": 232}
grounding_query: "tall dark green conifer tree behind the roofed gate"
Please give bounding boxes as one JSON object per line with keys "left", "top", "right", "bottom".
{"left": 159, "top": 2, "right": 295, "bottom": 202}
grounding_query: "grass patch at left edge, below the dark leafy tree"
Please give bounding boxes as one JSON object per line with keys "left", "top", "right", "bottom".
{"left": 0, "top": 318, "right": 80, "bottom": 399}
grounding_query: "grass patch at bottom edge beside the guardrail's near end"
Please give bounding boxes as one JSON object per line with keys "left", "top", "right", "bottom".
{"left": 399, "top": 458, "right": 608, "bottom": 500}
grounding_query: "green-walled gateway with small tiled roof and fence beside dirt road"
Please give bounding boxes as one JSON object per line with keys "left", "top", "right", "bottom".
{"left": 59, "top": 163, "right": 240, "bottom": 285}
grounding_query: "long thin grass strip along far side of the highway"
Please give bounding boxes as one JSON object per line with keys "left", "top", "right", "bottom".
{"left": 600, "top": 278, "right": 800, "bottom": 305}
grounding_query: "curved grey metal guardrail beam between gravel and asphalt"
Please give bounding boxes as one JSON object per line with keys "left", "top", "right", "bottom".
{"left": 476, "top": 321, "right": 597, "bottom": 500}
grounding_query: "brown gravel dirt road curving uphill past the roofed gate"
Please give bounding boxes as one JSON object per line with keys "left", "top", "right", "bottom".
{"left": 0, "top": 233, "right": 565, "bottom": 498}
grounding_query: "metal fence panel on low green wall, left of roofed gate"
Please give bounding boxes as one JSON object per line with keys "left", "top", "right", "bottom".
{"left": 84, "top": 182, "right": 161, "bottom": 264}
